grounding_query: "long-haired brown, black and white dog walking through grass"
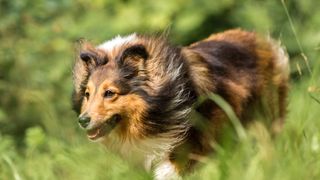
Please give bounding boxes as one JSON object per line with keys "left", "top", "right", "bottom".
{"left": 73, "top": 29, "right": 289, "bottom": 179}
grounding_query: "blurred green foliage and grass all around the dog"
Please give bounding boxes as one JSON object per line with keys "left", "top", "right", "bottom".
{"left": 0, "top": 0, "right": 320, "bottom": 179}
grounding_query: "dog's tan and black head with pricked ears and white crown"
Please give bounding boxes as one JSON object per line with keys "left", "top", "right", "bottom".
{"left": 73, "top": 34, "right": 148, "bottom": 140}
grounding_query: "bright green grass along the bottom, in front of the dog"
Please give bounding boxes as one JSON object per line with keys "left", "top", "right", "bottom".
{"left": 0, "top": 68, "right": 320, "bottom": 180}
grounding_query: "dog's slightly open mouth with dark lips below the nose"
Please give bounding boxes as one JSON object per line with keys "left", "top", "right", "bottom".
{"left": 87, "top": 114, "right": 121, "bottom": 140}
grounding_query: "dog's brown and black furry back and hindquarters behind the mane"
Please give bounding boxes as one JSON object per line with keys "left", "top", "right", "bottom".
{"left": 184, "top": 29, "right": 288, "bottom": 131}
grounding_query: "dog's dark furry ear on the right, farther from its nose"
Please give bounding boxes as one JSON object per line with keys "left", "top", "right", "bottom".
{"left": 118, "top": 45, "right": 149, "bottom": 79}
